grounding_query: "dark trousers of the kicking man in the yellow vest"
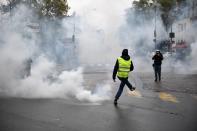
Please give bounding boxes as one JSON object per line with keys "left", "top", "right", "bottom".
{"left": 115, "top": 77, "right": 132, "bottom": 100}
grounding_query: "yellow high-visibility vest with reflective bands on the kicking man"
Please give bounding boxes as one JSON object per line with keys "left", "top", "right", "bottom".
{"left": 117, "top": 57, "right": 131, "bottom": 78}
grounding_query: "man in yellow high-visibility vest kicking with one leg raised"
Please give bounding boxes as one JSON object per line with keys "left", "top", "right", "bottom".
{"left": 112, "top": 49, "right": 135, "bottom": 105}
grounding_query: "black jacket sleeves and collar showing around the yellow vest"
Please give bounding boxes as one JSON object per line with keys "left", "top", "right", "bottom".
{"left": 112, "top": 53, "right": 134, "bottom": 80}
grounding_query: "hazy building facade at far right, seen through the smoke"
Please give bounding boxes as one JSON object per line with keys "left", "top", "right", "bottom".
{"left": 172, "top": 0, "right": 197, "bottom": 56}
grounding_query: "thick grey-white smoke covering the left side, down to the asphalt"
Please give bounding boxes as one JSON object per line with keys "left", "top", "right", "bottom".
{"left": 0, "top": 5, "right": 111, "bottom": 102}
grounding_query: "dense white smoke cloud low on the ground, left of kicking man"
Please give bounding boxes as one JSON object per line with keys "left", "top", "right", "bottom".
{"left": 16, "top": 56, "right": 111, "bottom": 102}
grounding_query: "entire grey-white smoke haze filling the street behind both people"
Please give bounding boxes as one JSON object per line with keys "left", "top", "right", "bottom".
{"left": 0, "top": 0, "right": 197, "bottom": 102}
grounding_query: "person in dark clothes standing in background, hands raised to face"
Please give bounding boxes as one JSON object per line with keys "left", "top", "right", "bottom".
{"left": 152, "top": 50, "right": 163, "bottom": 82}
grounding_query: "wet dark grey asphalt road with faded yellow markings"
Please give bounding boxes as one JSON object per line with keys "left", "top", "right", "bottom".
{"left": 0, "top": 72, "right": 197, "bottom": 131}
